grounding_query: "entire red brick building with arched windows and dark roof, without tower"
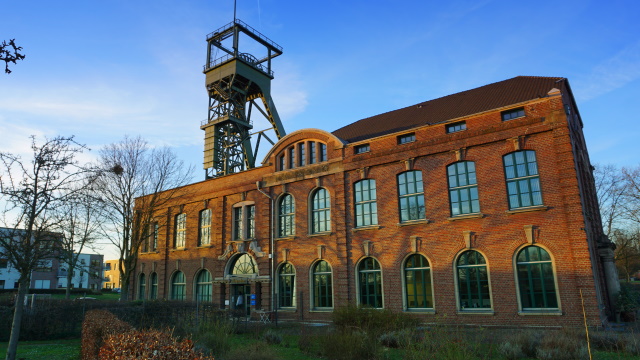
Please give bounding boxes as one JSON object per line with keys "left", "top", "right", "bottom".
{"left": 133, "top": 77, "right": 618, "bottom": 326}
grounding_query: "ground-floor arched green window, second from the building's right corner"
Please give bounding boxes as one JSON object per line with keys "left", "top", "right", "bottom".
{"left": 456, "top": 250, "right": 491, "bottom": 310}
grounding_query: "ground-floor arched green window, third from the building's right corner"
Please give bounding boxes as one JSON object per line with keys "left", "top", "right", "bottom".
{"left": 404, "top": 254, "right": 433, "bottom": 309}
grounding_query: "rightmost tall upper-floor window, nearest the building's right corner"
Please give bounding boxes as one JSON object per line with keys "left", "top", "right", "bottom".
{"left": 503, "top": 150, "right": 542, "bottom": 209}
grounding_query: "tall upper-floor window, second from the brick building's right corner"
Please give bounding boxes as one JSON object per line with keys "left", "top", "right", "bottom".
{"left": 447, "top": 161, "right": 480, "bottom": 216}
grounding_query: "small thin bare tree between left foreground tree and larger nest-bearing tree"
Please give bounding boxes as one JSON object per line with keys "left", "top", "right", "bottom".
{"left": 55, "top": 183, "right": 102, "bottom": 299}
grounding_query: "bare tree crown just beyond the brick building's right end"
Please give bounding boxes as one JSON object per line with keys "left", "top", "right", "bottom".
{"left": 593, "top": 164, "right": 626, "bottom": 236}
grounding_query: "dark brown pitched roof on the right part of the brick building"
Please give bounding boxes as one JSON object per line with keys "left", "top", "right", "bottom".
{"left": 333, "top": 76, "right": 565, "bottom": 142}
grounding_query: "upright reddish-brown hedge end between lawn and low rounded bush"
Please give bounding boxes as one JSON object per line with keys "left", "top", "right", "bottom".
{"left": 81, "top": 310, "right": 133, "bottom": 360}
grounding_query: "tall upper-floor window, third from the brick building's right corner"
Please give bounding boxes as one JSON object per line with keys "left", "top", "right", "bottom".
{"left": 398, "top": 171, "right": 426, "bottom": 222}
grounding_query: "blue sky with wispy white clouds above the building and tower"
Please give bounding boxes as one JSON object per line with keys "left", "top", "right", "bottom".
{"left": 0, "top": 0, "right": 640, "bottom": 256}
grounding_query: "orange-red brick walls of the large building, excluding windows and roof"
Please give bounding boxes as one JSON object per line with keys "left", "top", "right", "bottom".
{"left": 133, "top": 78, "right": 611, "bottom": 326}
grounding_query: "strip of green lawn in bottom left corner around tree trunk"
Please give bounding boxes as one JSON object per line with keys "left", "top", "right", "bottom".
{"left": 0, "top": 339, "right": 80, "bottom": 360}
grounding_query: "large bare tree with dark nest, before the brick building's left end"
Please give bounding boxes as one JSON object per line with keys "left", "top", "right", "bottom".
{"left": 96, "top": 137, "right": 193, "bottom": 300}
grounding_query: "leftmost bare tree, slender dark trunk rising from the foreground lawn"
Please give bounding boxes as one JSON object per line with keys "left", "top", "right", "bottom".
{"left": 0, "top": 137, "right": 84, "bottom": 360}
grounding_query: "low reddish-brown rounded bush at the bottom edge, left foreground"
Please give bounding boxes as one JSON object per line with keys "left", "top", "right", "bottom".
{"left": 98, "top": 330, "right": 213, "bottom": 360}
